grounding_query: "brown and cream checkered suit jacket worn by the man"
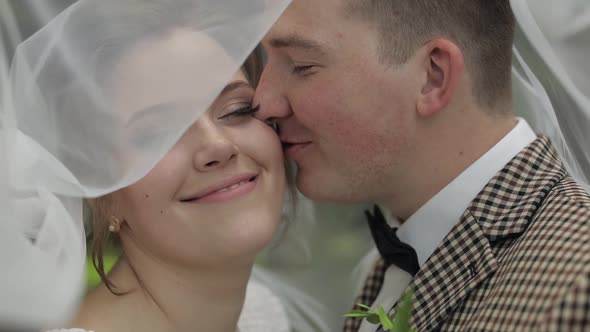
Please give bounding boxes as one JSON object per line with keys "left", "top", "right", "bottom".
{"left": 344, "top": 137, "right": 590, "bottom": 332}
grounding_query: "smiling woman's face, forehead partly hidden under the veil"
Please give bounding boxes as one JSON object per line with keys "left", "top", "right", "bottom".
{"left": 112, "top": 31, "right": 285, "bottom": 265}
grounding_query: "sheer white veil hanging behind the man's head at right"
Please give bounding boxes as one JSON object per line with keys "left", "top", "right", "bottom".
{"left": 511, "top": 0, "right": 590, "bottom": 190}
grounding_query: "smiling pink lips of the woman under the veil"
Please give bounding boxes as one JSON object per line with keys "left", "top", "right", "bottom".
{"left": 180, "top": 174, "right": 258, "bottom": 204}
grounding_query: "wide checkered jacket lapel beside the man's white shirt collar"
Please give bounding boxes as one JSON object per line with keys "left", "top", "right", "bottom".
{"left": 389, "top": 137, "right": 566, "bottom": 332}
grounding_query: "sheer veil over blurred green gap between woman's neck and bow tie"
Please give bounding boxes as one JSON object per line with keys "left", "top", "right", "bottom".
{"left": 253, "top": 196, "right": 372, "bottom": 332}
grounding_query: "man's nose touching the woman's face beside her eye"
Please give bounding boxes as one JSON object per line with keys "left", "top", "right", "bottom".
{"left": 254, "top": 64, "right": 293, "bottom": 123}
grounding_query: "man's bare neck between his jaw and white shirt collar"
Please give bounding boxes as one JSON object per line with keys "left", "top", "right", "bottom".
{"left": 381, "top": 106, "right": 516, "bottom": 220}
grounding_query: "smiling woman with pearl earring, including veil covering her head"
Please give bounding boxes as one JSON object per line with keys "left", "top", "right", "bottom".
{"left": 4, "top": 0, "right": 289, "bottom": 332}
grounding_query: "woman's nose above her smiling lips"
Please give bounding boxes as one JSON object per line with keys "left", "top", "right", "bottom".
{"left": 193, "top": 120, "right": 239, "bottom": 172}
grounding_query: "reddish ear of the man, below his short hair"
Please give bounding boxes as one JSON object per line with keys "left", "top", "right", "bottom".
{"left": 417, "top": 38, "right": 465, "bottom": 117}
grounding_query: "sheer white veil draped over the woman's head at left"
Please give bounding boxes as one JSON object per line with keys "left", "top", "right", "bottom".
{"left": 0, "top": 0, "right": 289, "bottom": 329}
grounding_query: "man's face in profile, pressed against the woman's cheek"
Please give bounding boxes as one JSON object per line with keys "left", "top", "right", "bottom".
{"left": 254, "top": 0, "right": 421, "bottom": 203}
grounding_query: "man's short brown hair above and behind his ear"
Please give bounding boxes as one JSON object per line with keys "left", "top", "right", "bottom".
{"left": 344, "top": 0, "right": 515, "bottom": 107}
